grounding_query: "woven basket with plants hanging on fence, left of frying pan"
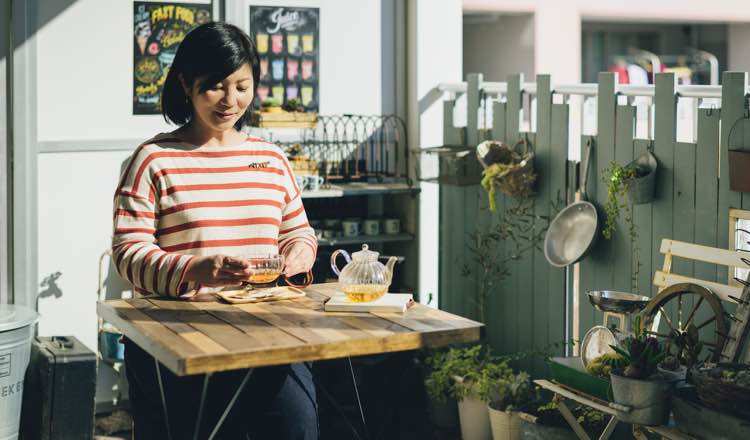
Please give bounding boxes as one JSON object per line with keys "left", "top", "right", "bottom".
{"left": 477, "top": 137, "right": 536, "bottom": 198}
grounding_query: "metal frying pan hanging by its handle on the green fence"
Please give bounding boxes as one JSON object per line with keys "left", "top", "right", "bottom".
{"left": 544, "top": 139, "right": 599, "bottom": 267}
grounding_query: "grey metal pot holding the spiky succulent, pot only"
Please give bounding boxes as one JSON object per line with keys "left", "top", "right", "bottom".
{"left": 609, "top": 369, "right": 672, "bottom": 426}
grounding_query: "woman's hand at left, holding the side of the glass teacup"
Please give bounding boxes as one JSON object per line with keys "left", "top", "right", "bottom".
{"left": 183, "top": 255, "right": 250, "bottom": 287}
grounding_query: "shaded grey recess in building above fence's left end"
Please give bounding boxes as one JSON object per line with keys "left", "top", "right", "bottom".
{"left": 463, "top": 14, "right": 535, "bottom": 81}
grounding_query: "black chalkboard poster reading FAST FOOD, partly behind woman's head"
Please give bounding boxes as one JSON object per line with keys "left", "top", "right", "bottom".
{"left": 133, "top": 2, "right": 212, "bottom": 115}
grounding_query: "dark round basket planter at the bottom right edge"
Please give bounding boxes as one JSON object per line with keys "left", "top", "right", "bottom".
{"left": 689, "top": 364, "right": 750, "bottom": 420}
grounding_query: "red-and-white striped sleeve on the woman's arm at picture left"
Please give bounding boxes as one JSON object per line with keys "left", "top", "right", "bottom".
{"left": 112, "top": 146, "right": 194, "bottom": 296}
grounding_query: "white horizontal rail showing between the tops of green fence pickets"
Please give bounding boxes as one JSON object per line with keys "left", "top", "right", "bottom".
{"left": 437, "top": 82, "right": 732, "bottom": 98}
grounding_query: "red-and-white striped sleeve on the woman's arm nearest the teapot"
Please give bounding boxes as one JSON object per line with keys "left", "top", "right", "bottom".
{"left": 279, "top": 157, "right": 318, "bottom": 255}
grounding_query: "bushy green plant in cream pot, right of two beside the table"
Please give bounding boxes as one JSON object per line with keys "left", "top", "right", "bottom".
{"left": 478, "top": 362, "right": 535, "bottom": 440}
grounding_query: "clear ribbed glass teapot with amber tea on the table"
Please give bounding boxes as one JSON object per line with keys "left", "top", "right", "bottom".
{"left": 331, "top": 244, "right": 396, "bottom": 302}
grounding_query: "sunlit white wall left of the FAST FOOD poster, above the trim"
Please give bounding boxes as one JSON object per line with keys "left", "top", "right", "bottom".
{"left": 36, "top": 0, "right": 214, "bottom": 141}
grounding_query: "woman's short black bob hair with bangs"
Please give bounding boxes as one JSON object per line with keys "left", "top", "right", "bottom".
{"left": 161, "top": 21, "right": 260, "bottom": 130}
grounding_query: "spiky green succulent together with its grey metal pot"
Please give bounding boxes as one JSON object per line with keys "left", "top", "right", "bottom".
{"left": 609, "top": 315, "right": 671, "bottom": 426}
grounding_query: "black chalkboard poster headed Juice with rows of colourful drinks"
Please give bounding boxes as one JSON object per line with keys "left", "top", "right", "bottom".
{"left": 250, "top": 6, "right": 320, "bottom": 112}
